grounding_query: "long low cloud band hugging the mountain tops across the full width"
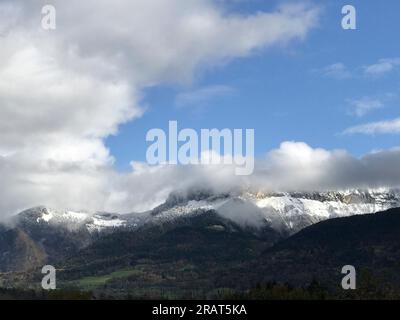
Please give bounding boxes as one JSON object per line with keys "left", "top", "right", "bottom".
{"left": 1, "top": 142, "right": 400, "bottom": 219}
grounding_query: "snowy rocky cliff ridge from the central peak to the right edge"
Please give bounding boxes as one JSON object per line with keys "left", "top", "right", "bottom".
{"left": 148, "top": 189, "right": 400, "bottom": 233}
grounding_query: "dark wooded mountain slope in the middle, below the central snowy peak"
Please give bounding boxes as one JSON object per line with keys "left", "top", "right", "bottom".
{"left": 56, "top": 211, "right": 282, "bottom": 275}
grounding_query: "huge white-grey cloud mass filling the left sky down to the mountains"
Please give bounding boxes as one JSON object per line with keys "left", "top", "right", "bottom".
{"left": 0, "top": 0, "right": 318, "bottom": 215}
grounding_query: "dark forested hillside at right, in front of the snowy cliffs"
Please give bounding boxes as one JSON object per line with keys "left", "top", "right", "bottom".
{"left": 228, "top": 209, "right": 400, "bottom": 289}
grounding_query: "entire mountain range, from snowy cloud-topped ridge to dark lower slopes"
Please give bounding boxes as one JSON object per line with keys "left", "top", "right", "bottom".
{"left": 0, "top": 189, "right": 400, "bottom": 298}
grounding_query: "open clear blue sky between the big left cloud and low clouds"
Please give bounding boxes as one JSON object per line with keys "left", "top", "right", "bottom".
{"left": 107, "top": 0, "right": 400, "bottom": 169}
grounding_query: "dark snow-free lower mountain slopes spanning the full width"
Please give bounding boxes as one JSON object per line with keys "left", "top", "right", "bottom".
{"left": 0, "top": 199, "right": 400, "bottom": 298}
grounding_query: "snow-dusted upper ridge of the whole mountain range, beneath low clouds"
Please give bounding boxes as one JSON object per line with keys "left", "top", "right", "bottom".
{"left": 10, "top": 189, "right": 400, "bottom": 234}
